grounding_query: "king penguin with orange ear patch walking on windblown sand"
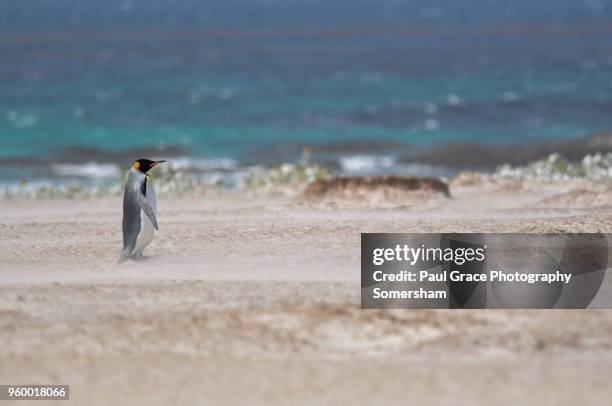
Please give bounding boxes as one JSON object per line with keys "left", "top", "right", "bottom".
{"left": 119, "top": 159, "right": 166, "bottom": 262}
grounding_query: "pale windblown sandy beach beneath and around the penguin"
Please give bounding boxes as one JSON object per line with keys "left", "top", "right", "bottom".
{"left": 0, "top": 184, "right": 612, "bottom": 405}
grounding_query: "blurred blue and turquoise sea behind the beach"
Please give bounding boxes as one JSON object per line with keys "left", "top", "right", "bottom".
{"left": 0, "top": 0, "right": 612, "bottom": 178}
